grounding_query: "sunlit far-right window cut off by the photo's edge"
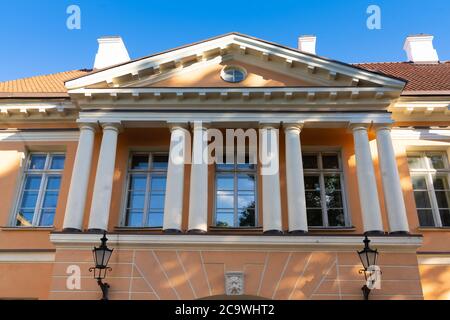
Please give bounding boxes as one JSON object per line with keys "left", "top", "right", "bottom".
{"left": 408, "top": 152, "right": 450, "bottom": 227}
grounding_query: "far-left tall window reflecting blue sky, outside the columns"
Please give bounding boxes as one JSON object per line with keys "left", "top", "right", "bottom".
{"left": 15, "top": 153, "right": 65, "bottom": 227}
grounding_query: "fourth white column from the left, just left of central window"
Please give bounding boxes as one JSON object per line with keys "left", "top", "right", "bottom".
{"left": 189, "top": 124, "right": 208, "bottom": 233}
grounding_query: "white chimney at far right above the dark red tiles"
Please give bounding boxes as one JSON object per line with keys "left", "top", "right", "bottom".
{"left": 403, "top": 34, "right": 439, "bottom": 63}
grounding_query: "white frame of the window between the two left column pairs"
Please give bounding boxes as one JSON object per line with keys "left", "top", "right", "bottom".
{"left": 120, "top": 150, "right": 169, "bottom": 229}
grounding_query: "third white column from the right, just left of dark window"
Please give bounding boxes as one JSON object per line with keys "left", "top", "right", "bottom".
{"left": 284, "top": 124, "right": 308, "bottom": 233}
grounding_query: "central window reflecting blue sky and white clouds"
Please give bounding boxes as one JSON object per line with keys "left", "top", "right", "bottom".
{"left": 215, "top": 155, "right": 257, "bottom": 228}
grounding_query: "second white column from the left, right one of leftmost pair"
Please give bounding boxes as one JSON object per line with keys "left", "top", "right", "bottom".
{"left": 89, "top": 123, "right": 120, "bottom": 230}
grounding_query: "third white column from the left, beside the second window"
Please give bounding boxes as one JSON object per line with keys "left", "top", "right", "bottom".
{"left": 163, "top": 125, "right": 190, "bottom": 232}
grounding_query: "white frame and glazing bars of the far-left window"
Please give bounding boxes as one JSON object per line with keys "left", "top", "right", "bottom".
{"left": 9, "top": 152, "right": 67, "bottom": 228}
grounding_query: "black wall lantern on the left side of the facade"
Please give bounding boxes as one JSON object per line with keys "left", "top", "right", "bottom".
{"left": 89, "top": 231, "right": 114, "bottom": 300}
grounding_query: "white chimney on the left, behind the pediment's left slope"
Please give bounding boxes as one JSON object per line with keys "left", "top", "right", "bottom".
{"left": 94, "top": 36, "right": 130, "bottom": 69}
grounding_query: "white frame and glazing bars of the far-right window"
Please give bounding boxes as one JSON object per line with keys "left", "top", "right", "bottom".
{"left": 407, "top": 150, "right": 450, "bottom": 228}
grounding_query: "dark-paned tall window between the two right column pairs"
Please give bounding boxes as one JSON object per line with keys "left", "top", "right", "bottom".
{"left": 302, "top": 152, "right": 346, "bottom": 227}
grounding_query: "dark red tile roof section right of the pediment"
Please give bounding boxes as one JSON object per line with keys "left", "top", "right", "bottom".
{"left": 354, "top": 61, "right": 450, "bottom": 95}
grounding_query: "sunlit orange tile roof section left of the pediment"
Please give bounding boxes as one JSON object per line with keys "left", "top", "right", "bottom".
{"left": 0, "top": 70, "right": 90, "bottom": 98}
